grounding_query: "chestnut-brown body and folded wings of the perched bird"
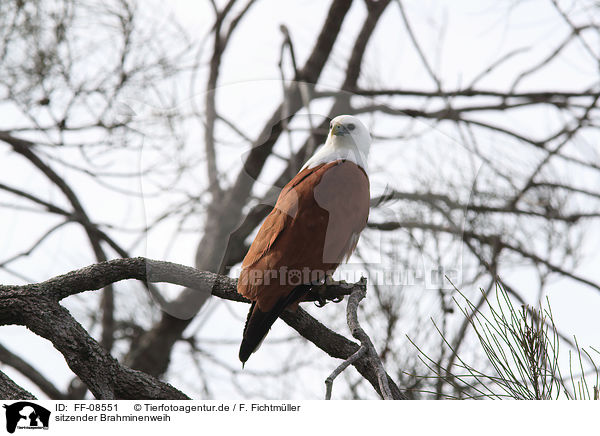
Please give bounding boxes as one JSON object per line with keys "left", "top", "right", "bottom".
{"left": 238, "top": 162, "right": 369, "bottom": 310}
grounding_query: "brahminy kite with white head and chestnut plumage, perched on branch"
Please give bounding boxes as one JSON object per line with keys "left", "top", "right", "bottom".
{"left": 237, "top": 115, "right": 371, "bottom": 363}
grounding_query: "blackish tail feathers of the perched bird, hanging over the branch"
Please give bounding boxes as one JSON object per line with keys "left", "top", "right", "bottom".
{"left": 239, "top": 285, "right": 310, "bottom": 364}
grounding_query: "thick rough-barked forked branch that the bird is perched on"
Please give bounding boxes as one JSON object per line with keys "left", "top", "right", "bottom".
{"left": 0, "top": 257, "right": 404, "bottom": 399}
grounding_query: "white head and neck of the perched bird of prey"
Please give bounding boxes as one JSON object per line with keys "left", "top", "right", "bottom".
{"left": 303, "top": 115, "right": 371, "bottom": 171}
